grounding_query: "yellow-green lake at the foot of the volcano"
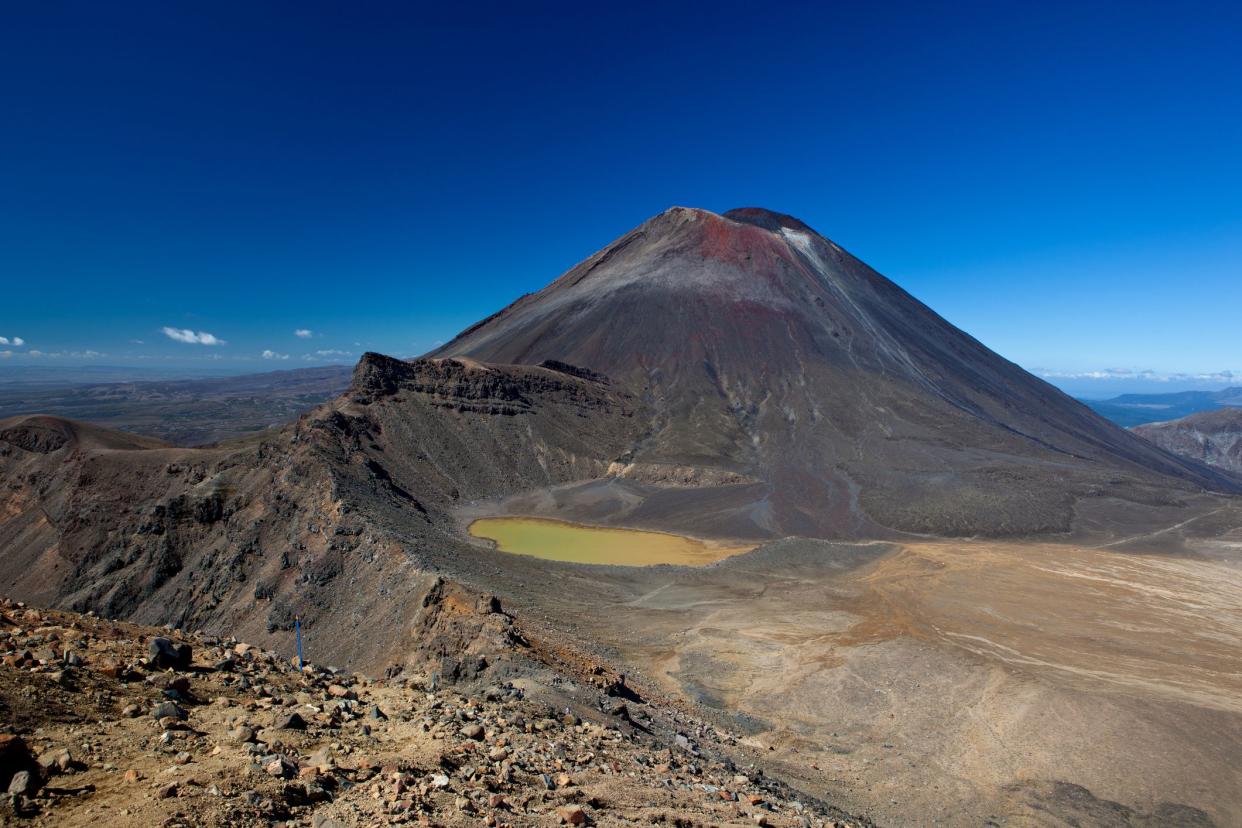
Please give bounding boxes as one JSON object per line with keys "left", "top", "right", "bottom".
{"left": 469, "top": 518, "right": 754, "bottom": 566}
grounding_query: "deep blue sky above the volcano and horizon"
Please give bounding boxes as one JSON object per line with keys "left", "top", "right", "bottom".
{"left": 0, "top": 2, "right": 1242, "bottom": 392}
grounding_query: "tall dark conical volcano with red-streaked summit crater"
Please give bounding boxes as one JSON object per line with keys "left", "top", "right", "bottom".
{"left": 433, "top": 207, "right": 1237, "bottom": 538}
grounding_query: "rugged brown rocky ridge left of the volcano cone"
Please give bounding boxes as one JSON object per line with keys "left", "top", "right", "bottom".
{"left": 0, "top": 354, "right": 640, "bottom": 664}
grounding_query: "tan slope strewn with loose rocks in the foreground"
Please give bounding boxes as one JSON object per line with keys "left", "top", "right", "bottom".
{"left": 0, "top": 602, "right": 869, "bottom": 828}
